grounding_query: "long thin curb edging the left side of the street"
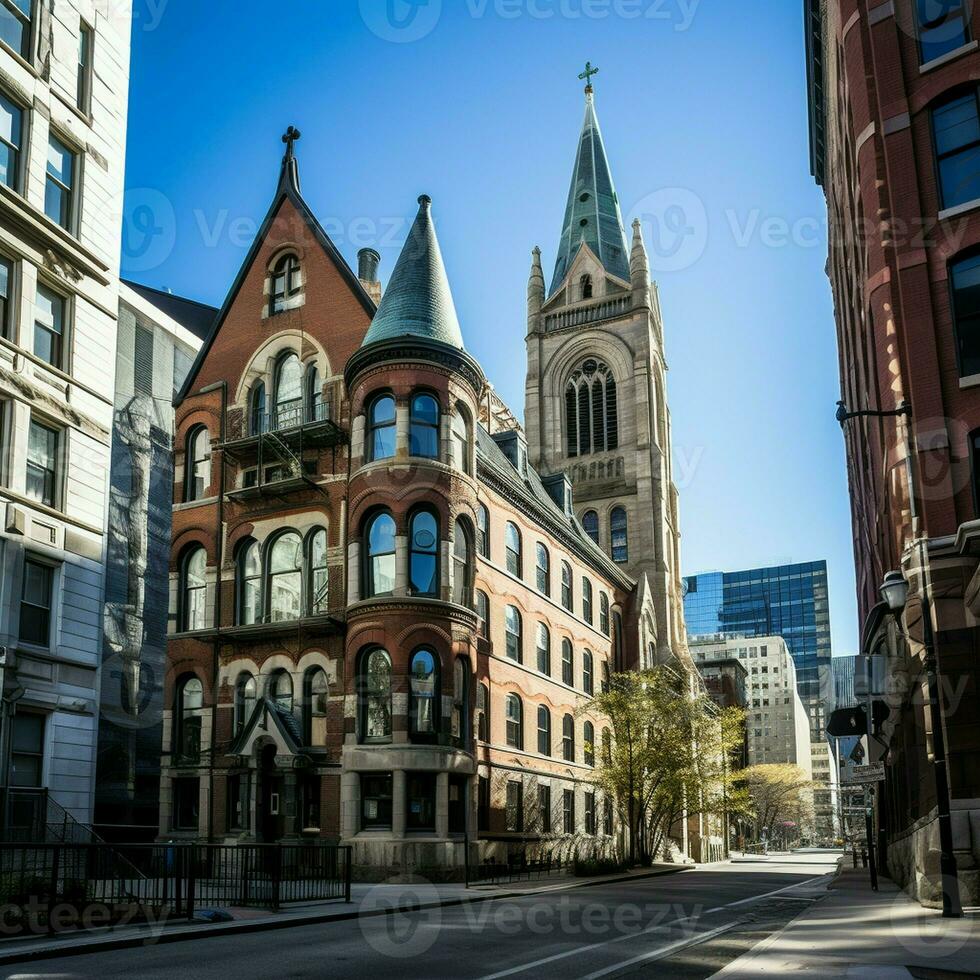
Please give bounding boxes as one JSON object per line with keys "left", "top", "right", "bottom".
{"left": 0, "top": 865, "right": 695, "bottom": 966}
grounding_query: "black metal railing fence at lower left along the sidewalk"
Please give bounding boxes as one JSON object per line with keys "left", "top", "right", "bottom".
{"left": 0, "top": 842, "right": 351, "bottom": 932}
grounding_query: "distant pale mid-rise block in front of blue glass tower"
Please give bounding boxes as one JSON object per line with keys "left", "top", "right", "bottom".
{"left": 689, "top": 636, "right": 813, "bottom": 779}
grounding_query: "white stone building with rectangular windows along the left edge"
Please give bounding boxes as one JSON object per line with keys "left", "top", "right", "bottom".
{"left": 0, "top": 0, "right": 131, "bottom": 835}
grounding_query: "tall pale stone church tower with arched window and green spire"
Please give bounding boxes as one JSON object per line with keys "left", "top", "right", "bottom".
{"left": 525, "top": 72, "right": 686, "bottom": 662}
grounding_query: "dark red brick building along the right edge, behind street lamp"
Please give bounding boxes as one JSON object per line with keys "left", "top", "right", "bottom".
{"left": 805, "top": 0, "right": 980, "bottom": 904}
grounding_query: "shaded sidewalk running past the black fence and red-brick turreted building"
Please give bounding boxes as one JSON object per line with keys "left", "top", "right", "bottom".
{"left": 0, "top": 864, "right": 694, "bottom": 965}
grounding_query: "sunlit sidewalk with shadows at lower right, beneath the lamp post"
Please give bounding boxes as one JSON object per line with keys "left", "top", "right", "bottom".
{"left": 715, "top": 867, "right": 980, "bottom": 980}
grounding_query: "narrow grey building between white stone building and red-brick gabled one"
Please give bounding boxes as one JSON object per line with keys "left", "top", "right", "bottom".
{"left": 94, "top": 282, "right": 218, "bottom": 842}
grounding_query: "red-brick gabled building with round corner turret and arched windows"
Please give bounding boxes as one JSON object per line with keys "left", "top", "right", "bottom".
{"left": 160, "top": 90, "right": 694, "bottom": 875}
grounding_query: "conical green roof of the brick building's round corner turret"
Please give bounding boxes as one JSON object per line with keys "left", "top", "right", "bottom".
{"left": 361, "top": 194, "right": 463, "bottom": 350}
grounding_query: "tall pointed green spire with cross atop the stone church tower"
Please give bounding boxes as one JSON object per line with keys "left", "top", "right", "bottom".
{"left": 548, "top": 82, "right": 630, "bottom": 296}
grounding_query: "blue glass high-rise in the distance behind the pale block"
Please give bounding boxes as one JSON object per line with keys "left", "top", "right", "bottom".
{"left": 684, "top": 561, "right": 832, "bottom": 739}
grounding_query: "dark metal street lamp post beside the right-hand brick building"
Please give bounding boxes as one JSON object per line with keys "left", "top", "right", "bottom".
{"left": 836, "top": 401, "right": 963, "bottom": 919}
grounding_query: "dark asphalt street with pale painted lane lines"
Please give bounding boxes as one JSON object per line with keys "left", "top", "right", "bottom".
{"left": 0, "top": 853, "right": 836, "bottom": 980}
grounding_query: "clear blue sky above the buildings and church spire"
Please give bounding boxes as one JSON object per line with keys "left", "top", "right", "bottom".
{"left": 123, "top": 0, "right": 857, "bottom": 654}
